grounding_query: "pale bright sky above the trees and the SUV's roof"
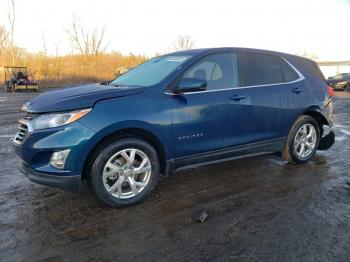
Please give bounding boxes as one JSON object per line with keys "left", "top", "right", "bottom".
{"left": 0, "top": 0, "right": 350, "bottom": 60}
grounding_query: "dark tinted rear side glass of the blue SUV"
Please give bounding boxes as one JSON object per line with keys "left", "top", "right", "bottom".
{"left": 246, "top": 53, "right": 299, "bottom": 86}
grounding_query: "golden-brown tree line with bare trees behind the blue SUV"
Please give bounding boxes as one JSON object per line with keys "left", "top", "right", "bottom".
{"left": 0, "top": 0, "right": 193, "bottom": 87}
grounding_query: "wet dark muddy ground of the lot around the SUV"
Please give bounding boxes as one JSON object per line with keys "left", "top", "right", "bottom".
{"left": 0, "top": 90, "right": 350, "bottom": 261}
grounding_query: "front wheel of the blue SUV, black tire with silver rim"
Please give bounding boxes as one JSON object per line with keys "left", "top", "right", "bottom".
{"left": 88, "top": 138, "right": 160, "bottom": 207}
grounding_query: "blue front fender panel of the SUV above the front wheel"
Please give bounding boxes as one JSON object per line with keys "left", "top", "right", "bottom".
{"left": 78, "top": 94, "right": 174, "bottom": 172}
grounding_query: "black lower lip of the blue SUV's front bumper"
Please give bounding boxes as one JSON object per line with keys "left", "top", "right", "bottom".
{"left": 18, "top": 161, "right": 81, "bottom": 192}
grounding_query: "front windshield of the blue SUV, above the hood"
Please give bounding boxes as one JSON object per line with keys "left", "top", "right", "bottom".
{"left": 110, "top": 55, "right": 191, "bottom": 87}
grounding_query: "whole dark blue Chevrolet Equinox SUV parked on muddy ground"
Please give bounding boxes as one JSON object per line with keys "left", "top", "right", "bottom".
{"left": 13, "top": 48, "right": 334, "bottom": 207}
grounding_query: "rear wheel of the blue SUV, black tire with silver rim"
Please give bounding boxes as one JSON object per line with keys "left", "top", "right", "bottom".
{"left": 282, "top": 115, "right": 321, "bottom": 163}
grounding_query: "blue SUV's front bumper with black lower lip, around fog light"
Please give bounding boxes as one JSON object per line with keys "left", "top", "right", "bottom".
{"left": 13, "top": 121, "right": 94, "bottom": 192}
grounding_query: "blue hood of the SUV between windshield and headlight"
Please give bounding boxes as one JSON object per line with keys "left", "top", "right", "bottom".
{"left": 22, "top": 84, "right": 144, "bottom": 113}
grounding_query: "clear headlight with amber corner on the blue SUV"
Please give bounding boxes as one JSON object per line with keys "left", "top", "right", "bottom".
{"left": 30, "top": 108, "right": 91, "bottom": 130}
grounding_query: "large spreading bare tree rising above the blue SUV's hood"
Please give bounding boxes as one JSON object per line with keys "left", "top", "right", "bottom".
{"left": 65, "top": 15, "right": 107, "bottom": 78}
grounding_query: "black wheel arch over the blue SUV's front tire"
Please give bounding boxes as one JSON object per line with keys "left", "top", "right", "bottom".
{"left": 82, "top": 127, "right": 167, "bottom": 179}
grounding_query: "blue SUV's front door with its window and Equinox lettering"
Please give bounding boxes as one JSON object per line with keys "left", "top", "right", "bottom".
{"left": 171, "top": 53, "right": 241, "bottom": 159}
